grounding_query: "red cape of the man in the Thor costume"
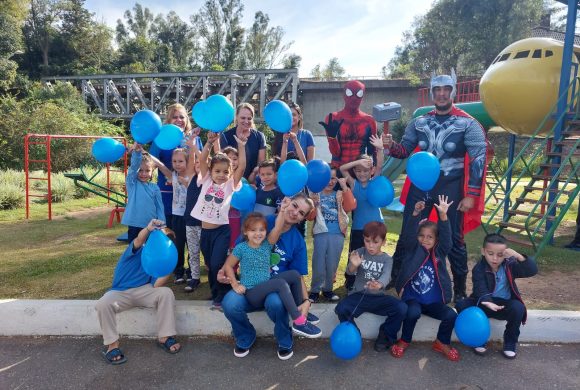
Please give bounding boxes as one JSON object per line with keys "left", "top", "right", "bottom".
{"left": 400, "top": 106, "right": 493, "bottom": 234}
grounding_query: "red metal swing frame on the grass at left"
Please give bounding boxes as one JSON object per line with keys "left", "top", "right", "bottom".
{"left": 24, "top": 133, "right": 127, "bottom": 220}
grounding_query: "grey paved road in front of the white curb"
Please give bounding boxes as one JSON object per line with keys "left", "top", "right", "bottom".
{"left": 0, "top": 337, "right": 580, "bottom": 390}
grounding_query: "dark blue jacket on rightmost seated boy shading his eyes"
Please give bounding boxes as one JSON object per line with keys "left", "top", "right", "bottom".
{"left": 471, "top": 255, "right": 538, "bottom": 324}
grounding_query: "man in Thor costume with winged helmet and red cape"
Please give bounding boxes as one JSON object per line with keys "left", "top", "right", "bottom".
{"left": 383, "top": 71, "right": 487, "bottom": 301}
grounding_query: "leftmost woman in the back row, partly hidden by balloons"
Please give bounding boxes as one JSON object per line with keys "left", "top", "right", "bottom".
{"left": 149, "top": 103, "right": 203, "bottom": 228}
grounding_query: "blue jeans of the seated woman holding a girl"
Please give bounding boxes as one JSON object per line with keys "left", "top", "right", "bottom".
{"left": 222, "top": 290, "right": 293, "bottom": 349}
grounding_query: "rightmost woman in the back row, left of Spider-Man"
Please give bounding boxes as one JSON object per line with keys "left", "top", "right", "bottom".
{"left": 274, "top": 102, "right": 315, "bottom": 162}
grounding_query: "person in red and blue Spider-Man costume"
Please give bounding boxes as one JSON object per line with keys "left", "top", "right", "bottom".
{"left": 318, "top": 80, "right": 377, "bottom": 169}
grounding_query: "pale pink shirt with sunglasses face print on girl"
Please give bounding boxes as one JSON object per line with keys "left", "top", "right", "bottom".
{"left": 191, "top": 172, "right": 242, "bottom": 225}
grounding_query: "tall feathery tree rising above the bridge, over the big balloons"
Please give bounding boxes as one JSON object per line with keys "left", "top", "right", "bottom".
{"left": 191, "top": 0, "right": 244, "bottom": 69}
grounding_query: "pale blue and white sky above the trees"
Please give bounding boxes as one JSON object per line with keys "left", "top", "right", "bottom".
{"left": 85, "top": 0, "right": 433, "bottom": 77}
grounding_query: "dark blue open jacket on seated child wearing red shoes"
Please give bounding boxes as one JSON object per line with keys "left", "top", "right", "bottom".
{"left": 395, "top": 215, "right": 453, "bottom": 303}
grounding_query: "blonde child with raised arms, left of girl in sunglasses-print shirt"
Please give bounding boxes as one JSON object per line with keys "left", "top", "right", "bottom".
{"left": 156, "top": 138, "right": 197, "bottom": 284}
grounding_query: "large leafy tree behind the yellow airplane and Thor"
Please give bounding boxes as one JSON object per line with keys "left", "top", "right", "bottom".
{"left": 387, "top": 0, "right": 544, "bottom": 78}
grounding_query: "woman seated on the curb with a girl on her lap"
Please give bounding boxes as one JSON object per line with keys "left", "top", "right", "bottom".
{"left": 218, "top": 193, "right": 319, "bottom": 360}
